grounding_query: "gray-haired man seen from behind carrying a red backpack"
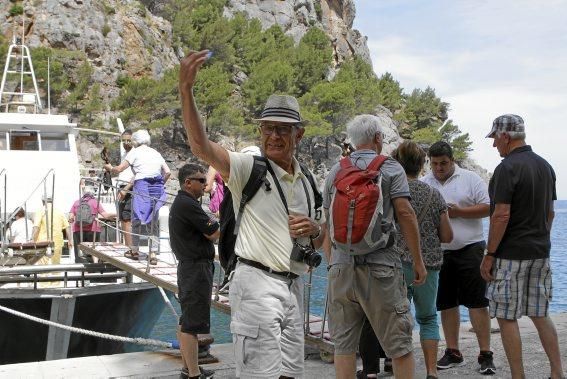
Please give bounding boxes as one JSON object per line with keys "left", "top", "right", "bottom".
{"left": 323, "top": 115, "right": 427, "bottom": 379}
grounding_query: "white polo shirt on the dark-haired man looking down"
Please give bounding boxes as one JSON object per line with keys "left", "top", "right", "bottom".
{"left": 421, "top": 164, "right": 490, "bottom": 250}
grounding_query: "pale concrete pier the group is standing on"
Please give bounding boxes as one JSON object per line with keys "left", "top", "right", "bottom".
{"left": 0, "top": 313, "right": 567, "bottom": 379}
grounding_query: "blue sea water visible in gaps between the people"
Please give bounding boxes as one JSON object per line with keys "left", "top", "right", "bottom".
{"left": 150, "top": 200, "right": 567, "bottom": 343}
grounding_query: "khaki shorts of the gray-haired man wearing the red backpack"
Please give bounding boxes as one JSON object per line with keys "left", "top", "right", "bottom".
{"left": 328, "top": 264, "right": 413, "bottom": 358}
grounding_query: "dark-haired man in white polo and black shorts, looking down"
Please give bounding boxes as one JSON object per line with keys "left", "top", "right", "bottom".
{"left": 422, "top": 141, "right": 495, "bottom": 375}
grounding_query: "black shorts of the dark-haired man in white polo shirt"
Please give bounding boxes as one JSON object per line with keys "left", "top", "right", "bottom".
{"left": 437, "top": 241, "right": 488, "bottom": 311}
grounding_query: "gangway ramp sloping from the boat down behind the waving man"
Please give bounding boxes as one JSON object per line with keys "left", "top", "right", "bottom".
{"left": 79, "top": 242, "right": 334, "bottom": 360}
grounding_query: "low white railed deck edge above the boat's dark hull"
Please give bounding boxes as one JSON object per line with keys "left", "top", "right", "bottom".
{"left": 0, "top": 263, "right": 127, "bottom": 289}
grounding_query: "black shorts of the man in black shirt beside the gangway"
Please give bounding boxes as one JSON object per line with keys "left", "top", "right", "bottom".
{"left": 177, "top": 260, "right": 214, "bottom": 334}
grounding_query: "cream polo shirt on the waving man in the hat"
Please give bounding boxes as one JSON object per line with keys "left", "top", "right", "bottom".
{"left": 227, "top": 152, "right": 323, "bottom": 274}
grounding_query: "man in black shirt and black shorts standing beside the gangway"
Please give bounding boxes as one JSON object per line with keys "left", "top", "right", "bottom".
{"left": 169, "top": 163, "right": 220, "bottom": 379}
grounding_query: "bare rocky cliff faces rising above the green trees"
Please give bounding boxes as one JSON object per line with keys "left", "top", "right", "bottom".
{"left": 0, "top": 0, "right": 370, "bottom": 98}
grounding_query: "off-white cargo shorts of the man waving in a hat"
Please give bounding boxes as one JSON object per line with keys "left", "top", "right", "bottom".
{"left": 229, "top": 262, "right": 304, "bottom": 378}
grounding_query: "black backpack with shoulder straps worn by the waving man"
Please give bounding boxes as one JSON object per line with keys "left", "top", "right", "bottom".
{"left": 218, "top": 155, "right": 323, "bottom": 288}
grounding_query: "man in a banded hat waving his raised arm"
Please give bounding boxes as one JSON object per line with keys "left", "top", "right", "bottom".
{"left": 179, "top": 50, "right": 325, "bottom": 378}
